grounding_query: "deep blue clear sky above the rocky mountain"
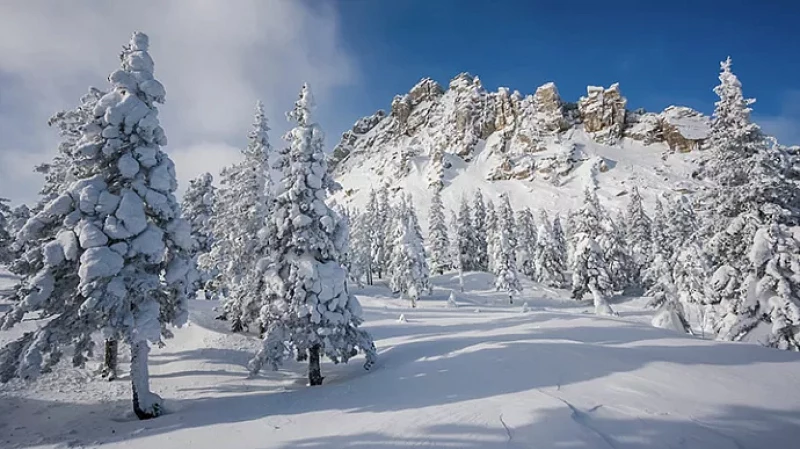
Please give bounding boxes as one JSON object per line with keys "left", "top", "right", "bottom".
{"left": 330, "top": 0, "right": 800, "bottom": 144}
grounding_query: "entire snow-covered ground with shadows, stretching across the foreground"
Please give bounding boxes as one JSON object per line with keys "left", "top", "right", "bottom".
{"left": 0, "top": 273, "right": 800, "bottom": 449}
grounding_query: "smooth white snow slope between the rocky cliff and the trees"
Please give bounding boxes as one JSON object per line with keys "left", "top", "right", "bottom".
{"left": 334, "top": 129, "right": 699, "bottom": 231}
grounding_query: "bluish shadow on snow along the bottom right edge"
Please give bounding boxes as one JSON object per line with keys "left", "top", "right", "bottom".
{"left": 270, "top": 404, "right": 800, "bottom": 449}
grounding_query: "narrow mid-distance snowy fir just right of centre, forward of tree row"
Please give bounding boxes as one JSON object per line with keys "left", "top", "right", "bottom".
{"left": 491, "top": 194, "right": 522, "bottom": 304}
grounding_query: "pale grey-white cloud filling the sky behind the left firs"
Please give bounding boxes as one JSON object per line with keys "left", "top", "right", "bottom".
{"left": 0, "top": 0, "right": 358, "bottom": 206}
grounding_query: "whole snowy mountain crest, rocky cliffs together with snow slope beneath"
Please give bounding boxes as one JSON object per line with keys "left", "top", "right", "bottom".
{"left": 329, "top": 73, "right": 709, "bottom": 220}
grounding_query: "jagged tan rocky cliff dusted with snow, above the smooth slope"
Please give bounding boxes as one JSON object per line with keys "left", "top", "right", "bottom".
{"left": 329, "top": 73, "right": 709, "bottom": 188}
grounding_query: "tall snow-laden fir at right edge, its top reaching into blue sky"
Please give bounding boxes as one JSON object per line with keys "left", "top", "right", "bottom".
{"left": 700, "top": 58, "right": 800, "bottom": 342}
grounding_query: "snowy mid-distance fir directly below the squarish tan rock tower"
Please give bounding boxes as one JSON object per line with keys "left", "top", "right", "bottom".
{"left": 571, "top": 188, "right": 614, "bottom": 314}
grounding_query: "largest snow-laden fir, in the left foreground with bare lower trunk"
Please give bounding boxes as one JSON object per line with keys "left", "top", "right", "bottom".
{"left": 0, "top": 33, "right": 194, "bottom": 419}
